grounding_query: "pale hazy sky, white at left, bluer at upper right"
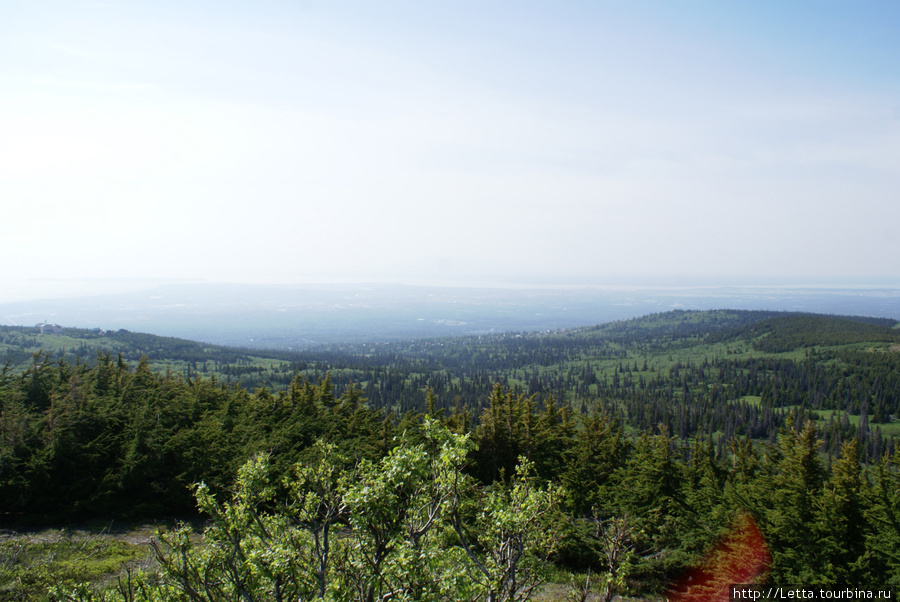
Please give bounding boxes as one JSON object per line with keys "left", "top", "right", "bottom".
{"left": 0, "top": 0, "right": 900, "bottom": 286}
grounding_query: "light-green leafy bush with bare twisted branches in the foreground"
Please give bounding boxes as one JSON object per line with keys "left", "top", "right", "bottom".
{"left": 51, "top": 419, "right": 559, "bottom": 602}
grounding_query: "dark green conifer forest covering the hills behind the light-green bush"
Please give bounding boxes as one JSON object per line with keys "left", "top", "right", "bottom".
{"left": 0, "top": 311, "right": 900, "bottom": 599}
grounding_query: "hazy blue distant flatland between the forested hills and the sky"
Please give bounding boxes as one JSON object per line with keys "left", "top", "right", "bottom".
{"left": 0, "top": 283, "right": 900, "bottom": 349}
